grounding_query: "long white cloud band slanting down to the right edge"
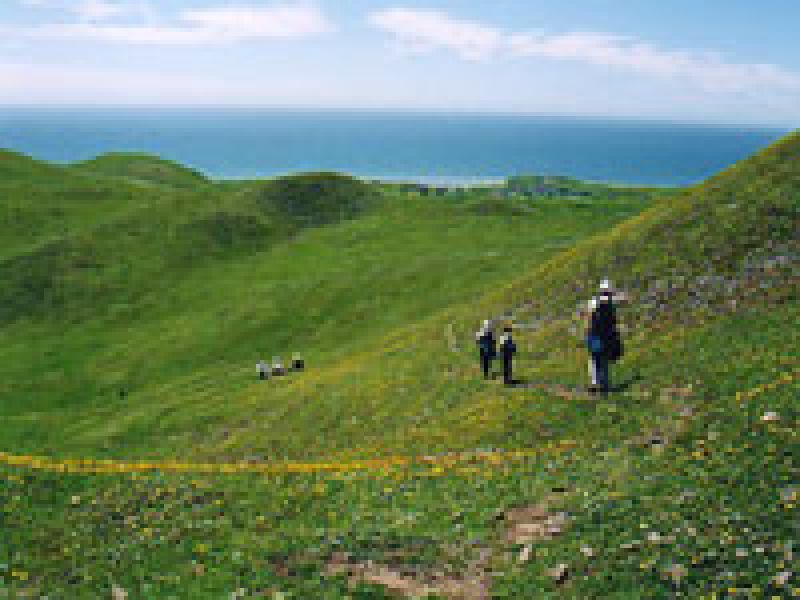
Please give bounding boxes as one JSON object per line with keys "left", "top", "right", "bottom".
{"left": 369, "top": 8, "right": 800, "bottom": 91}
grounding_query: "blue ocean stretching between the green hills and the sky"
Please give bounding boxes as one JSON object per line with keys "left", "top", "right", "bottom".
{"left": 0, "top": 107, "right": 788, "bottom": 185}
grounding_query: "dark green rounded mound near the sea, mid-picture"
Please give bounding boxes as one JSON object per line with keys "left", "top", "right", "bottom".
{"left": 257, "top": 173, "right": 376, "bottom": 227}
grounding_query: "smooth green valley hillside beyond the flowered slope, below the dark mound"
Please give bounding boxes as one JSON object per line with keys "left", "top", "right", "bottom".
{"left": 0, "top": 159, "right": 642, "bottom": 455}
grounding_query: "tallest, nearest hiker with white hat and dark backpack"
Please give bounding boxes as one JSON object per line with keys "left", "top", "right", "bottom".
{"left": 586, "top": 279, "right": 627, "bottom": 394}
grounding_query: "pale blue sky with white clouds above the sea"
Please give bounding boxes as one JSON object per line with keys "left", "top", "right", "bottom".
{"left": 0, "top": 0, "right": 800, "bottom": 127}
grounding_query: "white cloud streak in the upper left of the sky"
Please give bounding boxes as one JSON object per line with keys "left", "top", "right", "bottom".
{"left": 4, "top": 0, "right": 333, "bottom": 45}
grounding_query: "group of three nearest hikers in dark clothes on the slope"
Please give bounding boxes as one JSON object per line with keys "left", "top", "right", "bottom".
{"left": 475, "top": 279, "right": 627, "bottom": 394}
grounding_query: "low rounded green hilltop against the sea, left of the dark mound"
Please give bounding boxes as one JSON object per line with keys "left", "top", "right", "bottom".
{"left": 73, "top": 152, "right": 208, "bottom": 187}
